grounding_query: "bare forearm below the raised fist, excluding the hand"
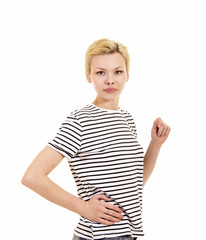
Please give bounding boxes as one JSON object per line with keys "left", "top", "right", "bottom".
{"left": 143, "top": 140, "right": 161, "bottom": 185}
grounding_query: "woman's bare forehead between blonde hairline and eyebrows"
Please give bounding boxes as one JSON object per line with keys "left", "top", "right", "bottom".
{"left": 91, "top": 52, "right": 125, "bottom": 69}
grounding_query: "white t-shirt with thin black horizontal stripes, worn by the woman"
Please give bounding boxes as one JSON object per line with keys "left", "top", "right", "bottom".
{"left": 48, "top": 104, "right": 144, "bottom": 239}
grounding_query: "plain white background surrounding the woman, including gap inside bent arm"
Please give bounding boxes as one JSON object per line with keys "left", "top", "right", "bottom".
{"left": 0, "top": 0, "right": 206, "bottom": 240}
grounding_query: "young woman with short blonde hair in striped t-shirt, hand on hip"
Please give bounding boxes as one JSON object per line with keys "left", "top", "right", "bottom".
{"left": 22, "top": 39, "right": 170, "bottom": 240}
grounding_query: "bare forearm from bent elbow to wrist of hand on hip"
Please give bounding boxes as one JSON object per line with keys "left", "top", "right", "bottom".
{"left": 22, "top": 176, "right": 85, "bottom": 215}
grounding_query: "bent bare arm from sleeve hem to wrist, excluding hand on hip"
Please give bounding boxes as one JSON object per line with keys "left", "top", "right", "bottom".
{"left": 22, "top": 146, "right": 84, "bottom": 214}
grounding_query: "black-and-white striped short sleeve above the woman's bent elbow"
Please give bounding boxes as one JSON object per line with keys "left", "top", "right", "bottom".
{"left": 48, "top": 113, "right": 82, "bottom": 159}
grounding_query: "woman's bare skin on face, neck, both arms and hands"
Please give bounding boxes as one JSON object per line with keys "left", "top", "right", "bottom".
{"left": 22, "top": 53, "right": 170, "bottom": 225}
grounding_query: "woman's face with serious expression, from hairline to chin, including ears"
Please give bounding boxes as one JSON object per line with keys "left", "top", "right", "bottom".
{"left": 87, "top": 52, "right": 129, "bottom": 101}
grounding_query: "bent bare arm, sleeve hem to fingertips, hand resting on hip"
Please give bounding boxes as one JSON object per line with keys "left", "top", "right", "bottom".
{"left": 22, "top": 146, "right": 122, "bottom": 225}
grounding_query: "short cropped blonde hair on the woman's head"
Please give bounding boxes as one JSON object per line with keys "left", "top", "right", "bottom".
{"left": 85, "top": 38, "right": 130, "bottom": 74}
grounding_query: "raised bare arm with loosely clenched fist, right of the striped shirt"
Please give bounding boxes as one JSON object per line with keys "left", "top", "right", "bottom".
{"left": 143, "top": 118, "right": 171, "bottom": 186}
